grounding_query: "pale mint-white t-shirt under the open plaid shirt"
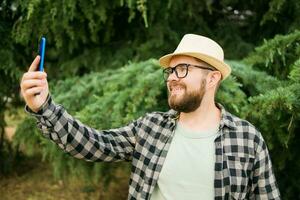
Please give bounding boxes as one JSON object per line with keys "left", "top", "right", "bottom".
{"left": 151, "top": 123, "right": 218, "bottom": 200}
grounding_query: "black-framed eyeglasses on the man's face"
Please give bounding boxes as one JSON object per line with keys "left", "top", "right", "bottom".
{"left": 163, "top": 63, "right": 216, "bottom": 81}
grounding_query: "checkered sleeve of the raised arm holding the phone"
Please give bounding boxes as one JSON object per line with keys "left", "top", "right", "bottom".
{"left": 25, "top": 96, "right": 140, "bottom": 162}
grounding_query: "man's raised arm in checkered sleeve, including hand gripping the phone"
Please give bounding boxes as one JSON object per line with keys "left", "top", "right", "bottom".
{"left": 20, "top": 56, "right": 139, "bottom": 161}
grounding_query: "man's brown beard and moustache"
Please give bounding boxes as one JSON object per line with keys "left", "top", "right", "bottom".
{"left": 168, "top": 79, "right": 206, "bottom": 113}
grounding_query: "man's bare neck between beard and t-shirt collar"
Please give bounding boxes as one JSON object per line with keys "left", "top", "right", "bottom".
{"left": 179, "top": 95, "right": 221, "bottom": 131}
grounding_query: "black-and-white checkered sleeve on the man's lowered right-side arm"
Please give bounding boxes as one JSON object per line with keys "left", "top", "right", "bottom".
{"left": 250, "top": 136, "right": 280, "bottom": 200}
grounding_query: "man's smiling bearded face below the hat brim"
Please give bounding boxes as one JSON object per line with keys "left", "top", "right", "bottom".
{"left": 167, "top": 56, "right": 209, "bottom": 113}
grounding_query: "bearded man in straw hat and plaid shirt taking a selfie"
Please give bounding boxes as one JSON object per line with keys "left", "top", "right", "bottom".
{"left": 21, "top": 34, "right": 280, "bottom": 200}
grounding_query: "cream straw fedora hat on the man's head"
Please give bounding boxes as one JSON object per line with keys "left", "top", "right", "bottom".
{"left": 159, "top": 34, "right": 231, "bottom": 80}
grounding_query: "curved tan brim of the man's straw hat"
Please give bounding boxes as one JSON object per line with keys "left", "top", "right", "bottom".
{"left": 159, "top": 52, "right": 231, "bottom": 80}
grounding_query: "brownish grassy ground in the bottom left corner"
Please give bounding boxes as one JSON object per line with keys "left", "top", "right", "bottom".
{"left": 0, "top": 158, "right": 102, "bottom": 200}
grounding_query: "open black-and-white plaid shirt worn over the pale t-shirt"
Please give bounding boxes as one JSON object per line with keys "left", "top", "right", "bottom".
{"left": 26, "top": 97, "right": 280, "bottom": 200}
